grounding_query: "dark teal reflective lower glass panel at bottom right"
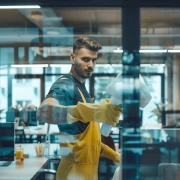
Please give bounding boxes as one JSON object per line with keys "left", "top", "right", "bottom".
{"left": 121, "top": 128, "right": 180, "bottom": 180}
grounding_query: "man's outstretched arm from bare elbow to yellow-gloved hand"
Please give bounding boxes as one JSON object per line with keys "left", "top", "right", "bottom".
{"left": 37, "top": 98, "right": 122, "bottom": 126}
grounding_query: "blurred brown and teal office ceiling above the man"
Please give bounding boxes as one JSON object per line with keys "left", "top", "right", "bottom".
{"left": 0, "top": 8, "right": 180, "bottom": 63}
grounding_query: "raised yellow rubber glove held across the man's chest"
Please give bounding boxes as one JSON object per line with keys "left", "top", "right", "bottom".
{"left": 67, "top": 100, "right": 122, "bottom": 126}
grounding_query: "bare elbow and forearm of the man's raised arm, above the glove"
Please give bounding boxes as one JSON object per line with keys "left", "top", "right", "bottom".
{"left": 36, "top": 98, "right": 68, "bottom": 124}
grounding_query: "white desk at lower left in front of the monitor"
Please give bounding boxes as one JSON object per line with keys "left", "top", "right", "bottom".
{"left": 0, "top": 144, "right": 60, "bottom": 180}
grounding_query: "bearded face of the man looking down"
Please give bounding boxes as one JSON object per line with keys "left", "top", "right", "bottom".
{"left": 71, "top": 48, "right": 98, "bottom": 79}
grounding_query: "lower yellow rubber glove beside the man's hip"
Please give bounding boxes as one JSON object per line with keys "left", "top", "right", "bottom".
{"left": 101, "top": 145, "right": 120, "bottom": 165}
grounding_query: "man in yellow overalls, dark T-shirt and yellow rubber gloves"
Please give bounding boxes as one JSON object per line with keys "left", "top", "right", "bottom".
{"left": 37, "top": 36, "right": 121, "bottom": 180}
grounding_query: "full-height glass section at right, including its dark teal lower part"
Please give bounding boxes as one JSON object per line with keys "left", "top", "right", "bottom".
{"left": 121, "top": 8, "right": 180, "bottom": 180}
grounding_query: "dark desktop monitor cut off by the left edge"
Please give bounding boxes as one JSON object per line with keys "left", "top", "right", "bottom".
{"left": 0, "top": 122, "right": 15, "bottom": 161}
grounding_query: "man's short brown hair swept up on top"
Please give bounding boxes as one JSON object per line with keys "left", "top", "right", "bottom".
{"left": 73, "top": 36, "right": 102, "bottom": 53}
